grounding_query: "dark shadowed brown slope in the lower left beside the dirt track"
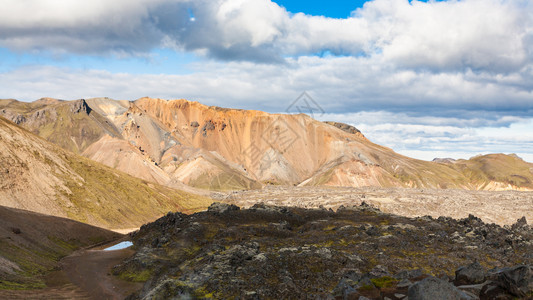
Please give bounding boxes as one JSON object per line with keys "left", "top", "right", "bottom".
{"left": 0, "top": 206, "right": 121, "bottom": 290}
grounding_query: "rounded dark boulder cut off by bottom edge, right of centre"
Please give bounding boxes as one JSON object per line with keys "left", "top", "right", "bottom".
{"left": 407, "top": 277, "right": 472, "bottom": 300}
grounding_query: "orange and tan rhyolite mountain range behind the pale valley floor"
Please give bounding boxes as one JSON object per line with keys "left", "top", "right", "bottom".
{"left": 0, "top": 98, "right": 533, "bottom": 190}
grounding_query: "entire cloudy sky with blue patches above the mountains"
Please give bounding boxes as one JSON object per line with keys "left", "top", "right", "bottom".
{"left": 0, "top": 0, "right": 533, "bottom": 162}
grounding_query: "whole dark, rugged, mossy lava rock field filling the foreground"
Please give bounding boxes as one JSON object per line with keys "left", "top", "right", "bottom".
{"left": 113, "top": 203, "right": 533, "bottom": 299}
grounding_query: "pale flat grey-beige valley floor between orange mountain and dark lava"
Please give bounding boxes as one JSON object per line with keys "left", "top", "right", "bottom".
{"left": 221, "top": 186, "right": 533, "bottom": 225}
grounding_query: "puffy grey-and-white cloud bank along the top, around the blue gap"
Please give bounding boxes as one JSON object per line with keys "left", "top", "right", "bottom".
{"left": 0, "top": 0, "right": 533, "bottom": 69}
